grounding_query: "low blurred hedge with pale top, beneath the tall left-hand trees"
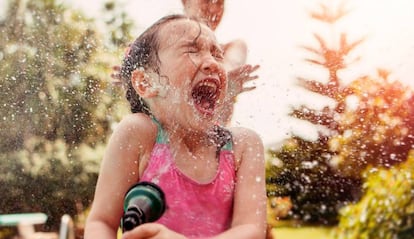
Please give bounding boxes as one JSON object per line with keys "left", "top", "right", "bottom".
{"left": 0, "top": 137, "right": 104, "bottom": 229}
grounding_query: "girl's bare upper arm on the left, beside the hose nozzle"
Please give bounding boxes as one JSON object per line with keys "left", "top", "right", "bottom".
{"left": 85, "top": 114, "right": 154, "bottom": 239}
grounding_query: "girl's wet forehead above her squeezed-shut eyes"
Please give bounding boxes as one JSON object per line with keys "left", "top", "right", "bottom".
{"left": 159, "top": 19, "right": 218, "bottom": 49}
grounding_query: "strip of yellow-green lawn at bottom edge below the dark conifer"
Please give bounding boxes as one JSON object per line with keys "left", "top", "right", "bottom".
{"left": 272, "top": 226, "right": 332, "bottom": 239}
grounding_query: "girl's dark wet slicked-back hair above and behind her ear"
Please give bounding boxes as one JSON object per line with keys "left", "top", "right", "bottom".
{"left": 121, "top": 14, "right": 188, "bottom": 115}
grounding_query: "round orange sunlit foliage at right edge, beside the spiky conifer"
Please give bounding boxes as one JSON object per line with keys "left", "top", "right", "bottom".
{"left": 329, "top": 73, "right": 414, "bottom": 177}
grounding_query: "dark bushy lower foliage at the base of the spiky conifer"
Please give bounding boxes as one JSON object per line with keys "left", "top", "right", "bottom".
{"left": 267, "top": 137, "right": 361, "bottom": 225}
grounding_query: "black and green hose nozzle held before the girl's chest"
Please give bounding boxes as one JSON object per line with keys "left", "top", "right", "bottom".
{"left": 121, "top": 182, "right": 166, "bottom": 232}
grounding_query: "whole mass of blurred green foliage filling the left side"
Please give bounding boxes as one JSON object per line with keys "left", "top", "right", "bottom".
{"left": 0, "top": 0, "right": 128, "bottom": 229}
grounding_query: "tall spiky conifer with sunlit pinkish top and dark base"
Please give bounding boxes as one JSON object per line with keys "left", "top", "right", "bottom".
{"left": 268, "top": 0, "right": 363, "bottom": 224}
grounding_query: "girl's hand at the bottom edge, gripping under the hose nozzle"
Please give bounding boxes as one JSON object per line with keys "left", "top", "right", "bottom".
{"left": 122, "top": 223, "right": 186, "bottom": 239}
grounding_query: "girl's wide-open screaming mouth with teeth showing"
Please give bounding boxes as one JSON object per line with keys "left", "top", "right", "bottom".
{"left": 191, "top": 78, "right": 220, "bottom": 115}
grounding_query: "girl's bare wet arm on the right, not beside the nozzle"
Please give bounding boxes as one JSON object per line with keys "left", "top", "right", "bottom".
{"left": 222, "top": 128, "right": 266, "bottom": 239}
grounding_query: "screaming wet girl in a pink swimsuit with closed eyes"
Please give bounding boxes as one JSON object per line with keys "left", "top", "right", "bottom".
{"left": 85, "top": 15, "right": 266, "bottom": 239}
